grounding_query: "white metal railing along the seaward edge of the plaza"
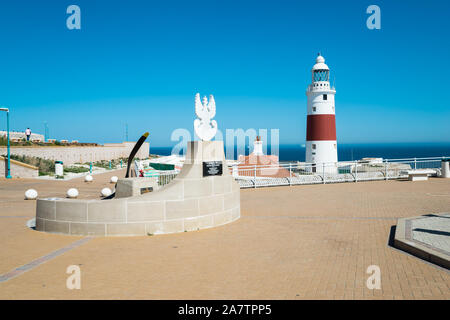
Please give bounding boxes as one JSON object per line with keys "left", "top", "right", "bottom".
{"left": 135, "top": 157, "right": 450, "bottom": 188}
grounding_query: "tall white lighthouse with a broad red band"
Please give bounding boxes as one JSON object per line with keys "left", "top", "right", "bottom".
{"left": 306, "top": 53, "right": 338, "bottom": 172}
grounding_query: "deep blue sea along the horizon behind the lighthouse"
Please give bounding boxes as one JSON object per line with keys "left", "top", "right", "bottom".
{"left": 150, "top": 142, "right": 450, "bottom": 162}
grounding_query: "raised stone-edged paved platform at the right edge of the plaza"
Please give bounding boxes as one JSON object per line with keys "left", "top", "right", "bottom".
{"left": 395, "top": 213, "right": 450, "bottom": 269}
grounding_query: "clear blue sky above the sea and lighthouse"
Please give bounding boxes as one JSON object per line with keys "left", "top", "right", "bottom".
{"left": 0, "top": 0, "right": 450, "bottom": 146}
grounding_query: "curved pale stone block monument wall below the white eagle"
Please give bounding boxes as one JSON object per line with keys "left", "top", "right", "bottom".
{"left": 36, "top": 141, "right": 240, "bottom": 236}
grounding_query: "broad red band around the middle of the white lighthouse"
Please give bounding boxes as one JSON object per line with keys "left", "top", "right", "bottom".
{"left": 306, "top": 114, "right": 336, "bottom": 141}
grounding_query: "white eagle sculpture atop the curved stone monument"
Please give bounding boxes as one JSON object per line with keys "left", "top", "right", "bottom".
{"left": 194, "top": 93, "right": 217, "bottom": 141}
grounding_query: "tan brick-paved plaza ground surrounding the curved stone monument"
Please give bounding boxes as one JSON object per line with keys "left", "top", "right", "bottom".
{"left": 0, "top": 171, "right": 450, "bottom": 299}
